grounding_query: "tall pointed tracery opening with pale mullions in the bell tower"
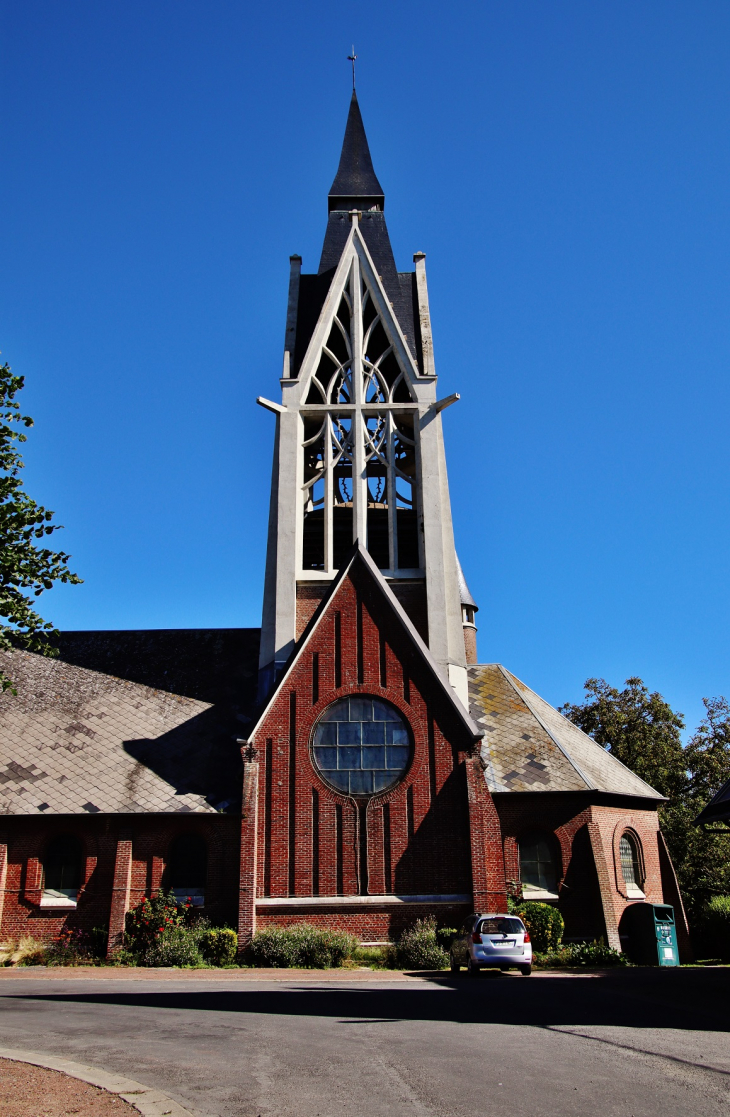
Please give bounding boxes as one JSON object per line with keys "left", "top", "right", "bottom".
{"left": 301, "top": 256, "right": 422, "bottom": 573}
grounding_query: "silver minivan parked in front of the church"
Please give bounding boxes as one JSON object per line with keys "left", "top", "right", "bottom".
{"left": 450, "top": 914, "right": 532, "bottom": 977}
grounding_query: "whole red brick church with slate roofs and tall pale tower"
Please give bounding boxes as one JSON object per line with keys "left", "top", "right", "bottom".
{"left": 0, "top": 92, "right": 690, "bottom": 957}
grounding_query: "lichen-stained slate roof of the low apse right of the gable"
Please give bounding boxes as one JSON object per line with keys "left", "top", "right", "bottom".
{"left": 468, "top": 663, "right": 663, "bottom": 801}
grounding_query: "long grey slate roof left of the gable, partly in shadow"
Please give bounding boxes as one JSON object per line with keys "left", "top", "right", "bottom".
{"left": 0, "top": 629, "right": 259, "bottom": 814}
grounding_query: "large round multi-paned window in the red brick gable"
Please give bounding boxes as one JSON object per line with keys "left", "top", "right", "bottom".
{"left": 311, "top": 695, "right": 411, "bottom": 795}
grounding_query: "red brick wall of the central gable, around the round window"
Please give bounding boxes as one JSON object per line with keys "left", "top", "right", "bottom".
{"left": 241, "top": 569, "right": 505, "bottom": 938}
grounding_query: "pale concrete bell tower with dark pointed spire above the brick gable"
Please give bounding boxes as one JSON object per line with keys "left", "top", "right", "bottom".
{"left": 258, "top": 90, "right": 468, "bottom": 706}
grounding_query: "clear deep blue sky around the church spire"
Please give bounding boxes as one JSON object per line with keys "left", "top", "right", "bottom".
{"left": 0, "top": 0, "right": 730, "bottom": 725}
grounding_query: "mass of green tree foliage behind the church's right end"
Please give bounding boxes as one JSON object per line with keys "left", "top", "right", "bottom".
{"left": 560, "top": 678, "right": 730, "bottom": 930}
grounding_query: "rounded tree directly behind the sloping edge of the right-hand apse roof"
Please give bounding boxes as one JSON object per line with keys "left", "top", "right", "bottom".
{"left": 559, "top": 678, "right": 686, "bottom": 799}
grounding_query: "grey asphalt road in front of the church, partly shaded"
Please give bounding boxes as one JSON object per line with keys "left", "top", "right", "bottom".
{"left": 0, "top": 970, "right": 730, "bottom": 1117}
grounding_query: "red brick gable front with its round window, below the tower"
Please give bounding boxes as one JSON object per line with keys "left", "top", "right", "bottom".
{"left": 246, "top": 548, "right": 478, "bottom": 897}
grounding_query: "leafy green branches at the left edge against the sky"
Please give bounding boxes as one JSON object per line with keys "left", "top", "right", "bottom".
{"left": 0, "top": 364, "right": 81, "bottom": 694}
